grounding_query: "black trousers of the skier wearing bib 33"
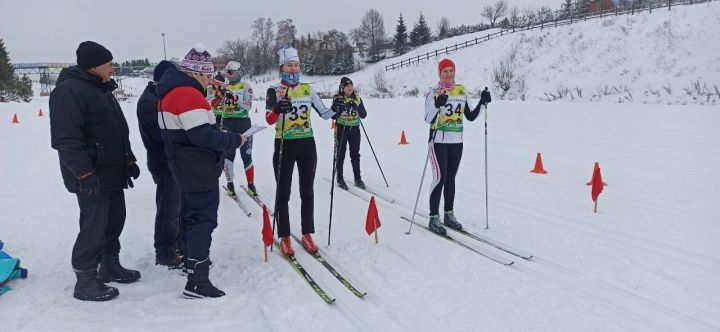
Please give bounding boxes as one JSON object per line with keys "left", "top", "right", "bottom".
{"left": 273, "top": 137, "right": 317, "bottom": 237}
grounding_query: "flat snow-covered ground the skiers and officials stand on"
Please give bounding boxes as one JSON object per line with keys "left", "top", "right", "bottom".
{"left": 0, "top": 72, "right": 720, "bottom": 331}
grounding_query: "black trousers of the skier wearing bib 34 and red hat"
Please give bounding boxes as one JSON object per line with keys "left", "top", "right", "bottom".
{"left": 430, "top": 143, "right": 463, "bottom": 215}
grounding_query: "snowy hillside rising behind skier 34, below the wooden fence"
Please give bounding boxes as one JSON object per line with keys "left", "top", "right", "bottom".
{"left": 294, "top": 1, "right": 720, "bottom": 104}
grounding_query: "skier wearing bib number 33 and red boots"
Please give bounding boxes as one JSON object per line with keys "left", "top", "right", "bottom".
{"left": 265, "top": 47, "right": 335, "bottom": 256}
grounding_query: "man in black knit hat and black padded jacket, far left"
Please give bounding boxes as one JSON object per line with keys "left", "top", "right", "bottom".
{"left": 50, "top": 41, "right": 140, "bottom": 301}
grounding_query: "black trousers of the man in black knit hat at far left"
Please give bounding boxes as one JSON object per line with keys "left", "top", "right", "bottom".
{"left": 72, "top": 189, "right": 125, "bottom": 270}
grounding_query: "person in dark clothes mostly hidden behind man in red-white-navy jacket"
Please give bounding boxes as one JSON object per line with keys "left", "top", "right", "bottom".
{"left": 137, "top": 61, "right": 183, "bottom": 268}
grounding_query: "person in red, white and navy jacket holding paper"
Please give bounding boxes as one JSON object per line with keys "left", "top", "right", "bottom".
{"left": 157, "top": 45, "right": 247, "bottom": 298}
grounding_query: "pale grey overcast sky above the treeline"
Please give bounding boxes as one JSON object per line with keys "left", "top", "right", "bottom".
{"left": 0, "top": 0, "right": 562, "bottom": 63}
